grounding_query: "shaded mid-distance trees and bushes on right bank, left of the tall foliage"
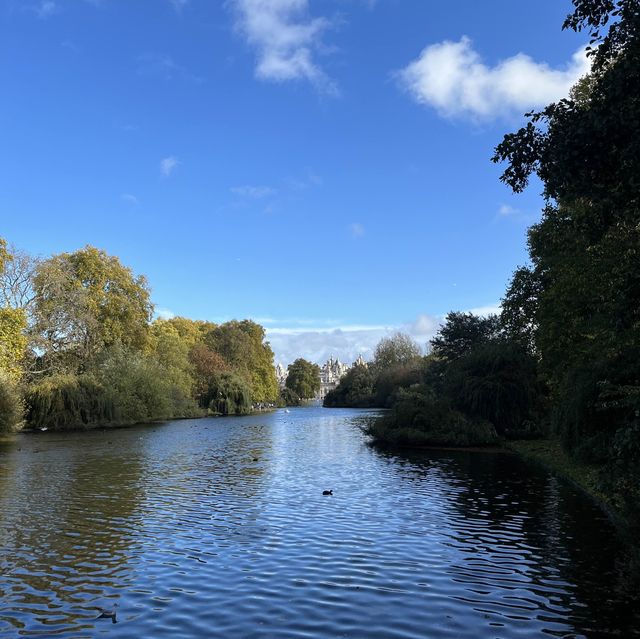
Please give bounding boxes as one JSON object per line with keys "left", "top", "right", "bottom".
{"left": 325, "top": 313, "right": 545, "bottom": 446}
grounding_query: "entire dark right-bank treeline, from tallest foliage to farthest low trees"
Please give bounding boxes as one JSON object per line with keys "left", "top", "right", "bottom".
{"left": 328, "top": 0, "right": 640, "bottom": 521}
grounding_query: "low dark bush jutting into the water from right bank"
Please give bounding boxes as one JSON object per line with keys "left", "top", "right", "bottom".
{"left": 367, "top": 386, "right": 498, "bottom": 446}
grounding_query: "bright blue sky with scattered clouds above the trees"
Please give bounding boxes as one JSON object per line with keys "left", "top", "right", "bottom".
{"left": 0, "top": 0, "right": 587, "bottom": 363}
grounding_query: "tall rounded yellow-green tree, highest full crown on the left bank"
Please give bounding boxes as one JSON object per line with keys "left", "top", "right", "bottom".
{"left": 33, "top": 246, "right": 153, "bottom": 372}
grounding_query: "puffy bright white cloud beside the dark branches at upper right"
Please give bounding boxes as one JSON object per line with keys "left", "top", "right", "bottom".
{"left": 398, "top": 36, "right": 589, "bottom": 119}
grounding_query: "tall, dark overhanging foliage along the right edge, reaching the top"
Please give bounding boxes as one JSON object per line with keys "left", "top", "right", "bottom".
{"left": 494, "top": 0, "right": 640, "bottom": 515}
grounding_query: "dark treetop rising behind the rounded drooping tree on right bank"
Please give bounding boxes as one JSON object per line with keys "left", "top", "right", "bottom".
{"left": 431, "top": 312, "right": 501, "bottom": 361}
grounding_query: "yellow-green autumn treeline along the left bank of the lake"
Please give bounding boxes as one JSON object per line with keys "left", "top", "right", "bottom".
{"left": 0, "top": 238, "right": 278, "bottom": 431}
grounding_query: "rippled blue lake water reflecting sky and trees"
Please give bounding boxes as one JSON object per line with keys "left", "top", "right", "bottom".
{"left": 0, "top": 408, "right": 640, "bottom": 639}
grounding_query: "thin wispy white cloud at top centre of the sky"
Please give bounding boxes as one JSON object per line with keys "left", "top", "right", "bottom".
{"left": 233, "top": 0, "right": 336, "bottom": 93}
